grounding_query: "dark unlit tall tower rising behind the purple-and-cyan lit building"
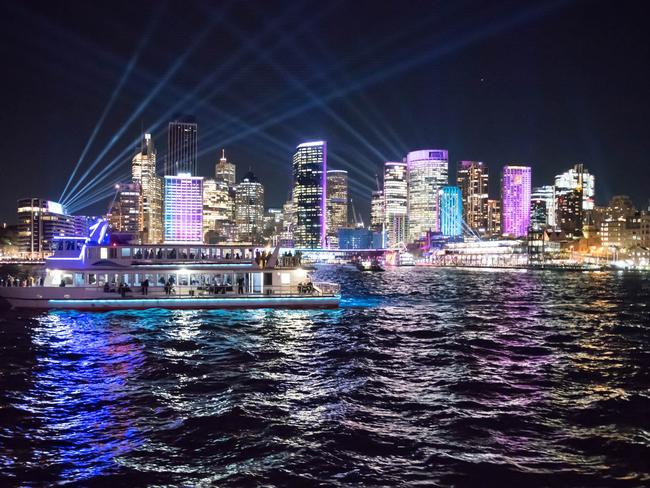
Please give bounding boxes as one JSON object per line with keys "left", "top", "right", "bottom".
{"left": 165, "top": 116, "right": 198, "bottom": 176}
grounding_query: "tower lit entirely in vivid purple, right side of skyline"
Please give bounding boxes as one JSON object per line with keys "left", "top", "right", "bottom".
{"left": 501, "top": 166, "right": 531, "bottom": 237}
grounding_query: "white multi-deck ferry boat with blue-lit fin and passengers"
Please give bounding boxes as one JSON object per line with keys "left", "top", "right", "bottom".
{"left": 0, "top": 221, "right": 340, "bottom": 310}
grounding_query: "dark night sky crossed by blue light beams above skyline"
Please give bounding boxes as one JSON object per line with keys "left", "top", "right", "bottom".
{"left": 0, "top": 0, "right": 650, "bottom": 223}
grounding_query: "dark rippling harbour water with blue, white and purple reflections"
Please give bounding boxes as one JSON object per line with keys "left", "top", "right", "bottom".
{"left": 0, "top": 269, "right": 650, "bottom": 486}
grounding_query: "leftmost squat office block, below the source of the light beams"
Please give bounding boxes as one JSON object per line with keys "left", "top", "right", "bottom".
{"left": 17, "top": 198, "right": 75, "bottom": 259}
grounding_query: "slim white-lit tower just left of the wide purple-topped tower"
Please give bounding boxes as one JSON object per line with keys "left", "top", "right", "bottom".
{"left": 377, "top": 162, "right": 408, "bottom": 247}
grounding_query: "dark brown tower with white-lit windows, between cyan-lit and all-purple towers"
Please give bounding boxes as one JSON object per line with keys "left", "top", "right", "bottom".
{"left": 456, "top": 161, "right": 489, "bottom": 235}
